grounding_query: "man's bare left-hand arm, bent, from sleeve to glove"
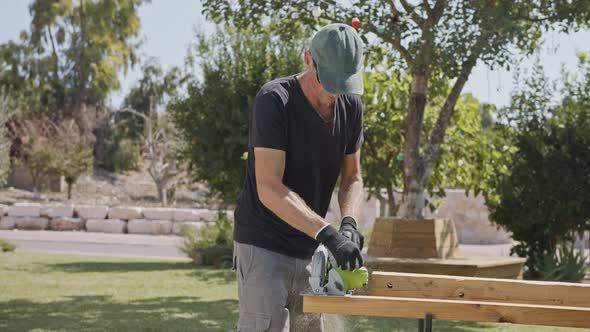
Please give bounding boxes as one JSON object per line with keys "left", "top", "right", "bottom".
{"left": 254, "top": 148, "right": 328, "bottom": 238}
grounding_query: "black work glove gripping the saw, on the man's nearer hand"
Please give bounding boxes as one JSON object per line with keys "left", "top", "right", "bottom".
{"left": 316, "top": 225, "right": 363, "bottom": 271}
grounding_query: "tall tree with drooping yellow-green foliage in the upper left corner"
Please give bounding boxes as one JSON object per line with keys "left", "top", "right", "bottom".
{"left": 0, "top": 0, "right": 143, "bottom": 123}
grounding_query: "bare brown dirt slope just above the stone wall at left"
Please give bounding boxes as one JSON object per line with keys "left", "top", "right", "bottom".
{"left": 0, "top": 165, "right": 222, "bottom": 208}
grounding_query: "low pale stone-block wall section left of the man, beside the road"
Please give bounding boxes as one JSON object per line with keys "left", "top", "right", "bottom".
{"left": 0, "top": 203, "right": 222, "bottom": 235}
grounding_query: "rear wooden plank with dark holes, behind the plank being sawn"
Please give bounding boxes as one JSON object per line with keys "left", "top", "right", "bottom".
{"left": 368, "top": 271, "right": 590, "bottom": 308}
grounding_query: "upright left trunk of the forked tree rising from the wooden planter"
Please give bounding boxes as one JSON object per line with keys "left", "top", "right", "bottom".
{"left": 399, "top": 65, "right": 428, "bottom": 219}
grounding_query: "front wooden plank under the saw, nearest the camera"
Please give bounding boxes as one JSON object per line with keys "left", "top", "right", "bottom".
{"left": 303, "top": 295, "right": 590, "bottom": 327}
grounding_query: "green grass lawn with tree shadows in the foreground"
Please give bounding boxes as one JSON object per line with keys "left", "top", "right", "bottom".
{"left": 0, "top": 252, "right": 582, "bottom": 332}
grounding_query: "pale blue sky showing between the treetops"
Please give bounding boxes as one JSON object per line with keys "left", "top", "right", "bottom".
{"left": 0, "top": 0, "right": 590, "bottom": 106}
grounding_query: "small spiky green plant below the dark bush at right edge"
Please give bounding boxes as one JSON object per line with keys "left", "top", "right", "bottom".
{"left": 537, "top": 241, "right": 588, "bottom": 282}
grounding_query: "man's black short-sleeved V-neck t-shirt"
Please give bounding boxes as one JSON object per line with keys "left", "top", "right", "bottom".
{"left": 234, "top": 76, "right": 363, "bottom": 259}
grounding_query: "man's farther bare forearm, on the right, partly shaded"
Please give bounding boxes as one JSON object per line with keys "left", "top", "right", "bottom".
{"left": 338, "top": 149, "right": 363, "bottom": 220}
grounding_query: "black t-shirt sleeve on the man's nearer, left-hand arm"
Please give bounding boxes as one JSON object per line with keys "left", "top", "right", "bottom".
{"left": 250, "top": 93, "right": 287, "bottom": 151}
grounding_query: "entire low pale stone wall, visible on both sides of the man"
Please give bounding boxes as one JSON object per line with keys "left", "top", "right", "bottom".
{"left": 0, "top": 189, "right": 511, "bottom": 244}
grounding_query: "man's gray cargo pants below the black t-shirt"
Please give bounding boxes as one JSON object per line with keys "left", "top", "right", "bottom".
{"left": 234, "top": 242, "right": 323, "bottom": 332}
